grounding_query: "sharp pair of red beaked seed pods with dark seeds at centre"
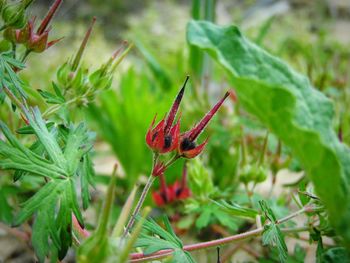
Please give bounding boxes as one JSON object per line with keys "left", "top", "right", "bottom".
{"left": 146, "top": 76, "right": 230, "bottom": 176}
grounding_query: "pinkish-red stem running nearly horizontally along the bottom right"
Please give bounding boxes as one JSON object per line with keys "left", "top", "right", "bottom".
{"left": 130, "top": 206, "right": 314, "bottom": 262}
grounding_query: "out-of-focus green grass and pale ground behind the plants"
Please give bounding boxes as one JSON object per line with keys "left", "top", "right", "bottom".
{"left": 0, "top": 0, "right": 350, "bottom": 262}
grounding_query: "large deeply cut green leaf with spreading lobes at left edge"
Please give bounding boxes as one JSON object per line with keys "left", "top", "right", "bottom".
{"left": 0, "top": 108, "right": 93, "bottom": 262}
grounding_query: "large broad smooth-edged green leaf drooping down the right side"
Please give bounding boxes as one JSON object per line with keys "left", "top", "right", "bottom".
{"left": 187, "top": 21, "right": 350, "bottom": 247}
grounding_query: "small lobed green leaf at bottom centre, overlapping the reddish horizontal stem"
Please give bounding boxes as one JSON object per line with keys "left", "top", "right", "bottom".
{"left": 135, "top": 216, "right": 195, "bottom": 263}
